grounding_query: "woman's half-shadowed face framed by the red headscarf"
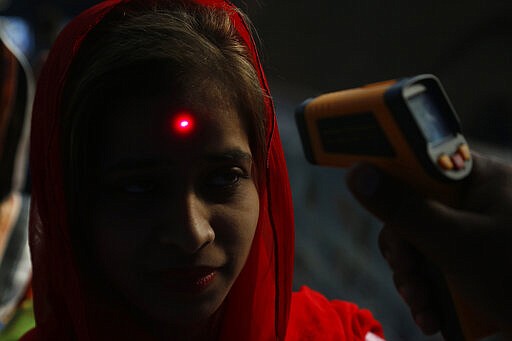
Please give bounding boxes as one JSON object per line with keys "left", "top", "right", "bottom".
{"left": 88, "top": 82, "right": 259, "bottom": 325}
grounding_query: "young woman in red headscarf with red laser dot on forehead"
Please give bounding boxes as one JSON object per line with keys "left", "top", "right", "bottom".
{"left": 25, "top": 0, "right": 382, "bottom": 340}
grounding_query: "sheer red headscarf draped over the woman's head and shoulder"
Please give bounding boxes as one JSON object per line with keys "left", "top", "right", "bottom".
{"left": 24, "top": 0, "right": 382, "bottom": 341}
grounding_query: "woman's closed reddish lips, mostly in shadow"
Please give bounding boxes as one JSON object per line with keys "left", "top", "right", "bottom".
{"left": 156, "top": 267, "right": 218, "bottom": 294}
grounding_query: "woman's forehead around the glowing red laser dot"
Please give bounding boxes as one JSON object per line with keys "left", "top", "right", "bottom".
{"left": 93, "top": 88, "right": 250, "bottom": 167}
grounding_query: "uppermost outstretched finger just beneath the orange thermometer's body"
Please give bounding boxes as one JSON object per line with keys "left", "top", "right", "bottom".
{"left": 346, "top": 164, "right": 489, "bottom": 268}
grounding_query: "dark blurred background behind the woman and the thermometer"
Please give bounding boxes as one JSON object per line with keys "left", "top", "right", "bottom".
{"left": 0, "top": 0, "right": 512, "bottom": 340}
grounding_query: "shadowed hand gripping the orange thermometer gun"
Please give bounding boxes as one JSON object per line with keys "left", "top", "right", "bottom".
{"left": 347, "top": 154, "right": 512, "bottom": 334}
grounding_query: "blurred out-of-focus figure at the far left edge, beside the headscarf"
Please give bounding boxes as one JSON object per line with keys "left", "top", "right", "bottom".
{"left": 0, "top": 20, "right": 34, "bottom": 340}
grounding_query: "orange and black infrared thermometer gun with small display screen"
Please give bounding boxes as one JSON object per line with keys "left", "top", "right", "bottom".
{"left": 295, "top": 74, "right": 493, "bottom": 340}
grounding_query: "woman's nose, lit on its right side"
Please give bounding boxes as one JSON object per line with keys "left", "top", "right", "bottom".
{"left": 160, "top": 194, "right": 215, "bottom": 254}
